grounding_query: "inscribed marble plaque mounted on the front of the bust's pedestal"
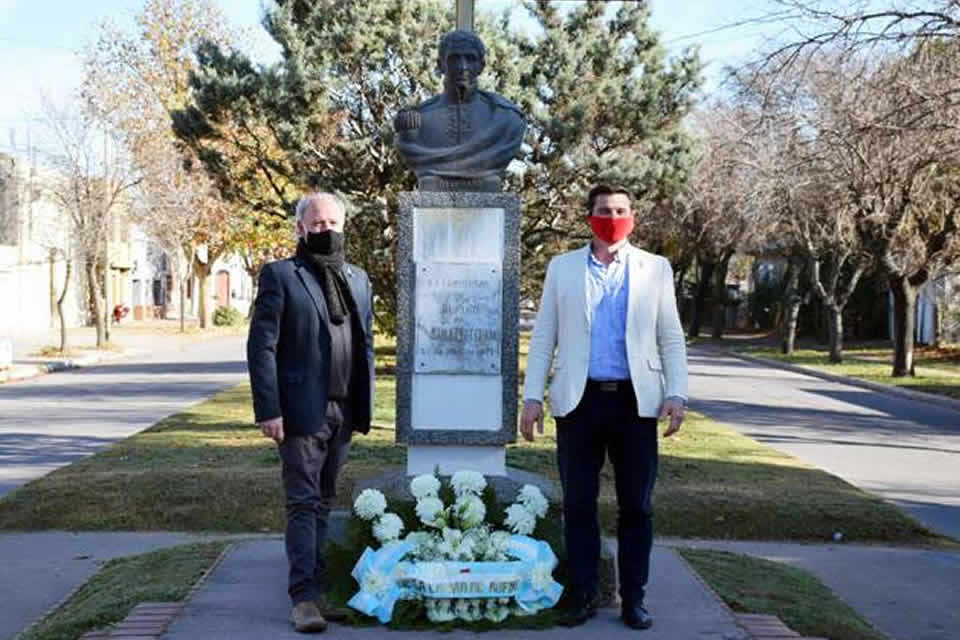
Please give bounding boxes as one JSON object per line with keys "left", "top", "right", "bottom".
{"left": 414, "top": 262, "right": 503, "bottom": 375}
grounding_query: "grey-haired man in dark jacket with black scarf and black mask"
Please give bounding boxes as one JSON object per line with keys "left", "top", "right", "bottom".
{"left": 247, "top": 193, "right": 373, "bottom": 632}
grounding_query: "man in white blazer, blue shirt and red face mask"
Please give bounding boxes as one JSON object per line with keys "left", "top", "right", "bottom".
{"left": 520, "top": 185, "right": 687, "bottom": 629}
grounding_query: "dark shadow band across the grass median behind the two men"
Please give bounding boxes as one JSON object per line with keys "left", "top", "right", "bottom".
{"left": 0, "top": 438, "right": 936, "bottom": 543}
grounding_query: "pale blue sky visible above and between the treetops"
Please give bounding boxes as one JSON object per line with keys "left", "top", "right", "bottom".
{"left": 0, "top": 0, "right": 777, "bottom": 151}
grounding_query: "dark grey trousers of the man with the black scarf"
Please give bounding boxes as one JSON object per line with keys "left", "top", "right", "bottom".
{"left": 279, "top": 402, "right": 351, "bottom": 604}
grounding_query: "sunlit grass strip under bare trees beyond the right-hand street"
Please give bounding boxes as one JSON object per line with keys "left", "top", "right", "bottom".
{"left": 743, "top": 347, "right": 960, "bottom": 398}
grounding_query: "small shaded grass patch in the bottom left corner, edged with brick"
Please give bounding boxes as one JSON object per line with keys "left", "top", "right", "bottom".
{"left": 17, "top": 542, "right": 227, "bottom": 640}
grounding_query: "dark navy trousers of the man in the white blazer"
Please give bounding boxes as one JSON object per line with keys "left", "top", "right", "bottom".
{"left": 557, "top": 381, "right": 657, "bottom": 605}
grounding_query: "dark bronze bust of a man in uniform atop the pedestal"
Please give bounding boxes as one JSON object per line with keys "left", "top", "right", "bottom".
{"left": 393, "top": 30, "right": 527, "bottom": 191}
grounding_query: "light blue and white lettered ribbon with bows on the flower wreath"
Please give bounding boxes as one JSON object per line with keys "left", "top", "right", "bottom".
{"left": 347, "top": 535, "right": 563, "bottom": 624}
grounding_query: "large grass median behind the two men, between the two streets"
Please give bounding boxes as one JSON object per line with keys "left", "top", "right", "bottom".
{"left": 0, "top": 375, "right": 942, "bottom": 544}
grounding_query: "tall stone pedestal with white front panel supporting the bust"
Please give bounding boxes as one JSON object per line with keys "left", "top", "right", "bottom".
{"left": 397, "top": 191, "right": 520, "bottom": 476}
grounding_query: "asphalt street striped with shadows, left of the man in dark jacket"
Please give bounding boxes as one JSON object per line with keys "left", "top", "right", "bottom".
{"left": 0, "top": 334, "right": 246, "bottom": 497}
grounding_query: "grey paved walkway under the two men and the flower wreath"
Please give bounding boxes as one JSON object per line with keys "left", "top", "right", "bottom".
{"left": 163, "top": 538, "right": 747, "bottom": 640}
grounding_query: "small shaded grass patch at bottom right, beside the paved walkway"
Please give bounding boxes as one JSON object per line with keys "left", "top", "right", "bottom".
{"left": 677, "top": 548, "right": 887, "bottom": 640}
